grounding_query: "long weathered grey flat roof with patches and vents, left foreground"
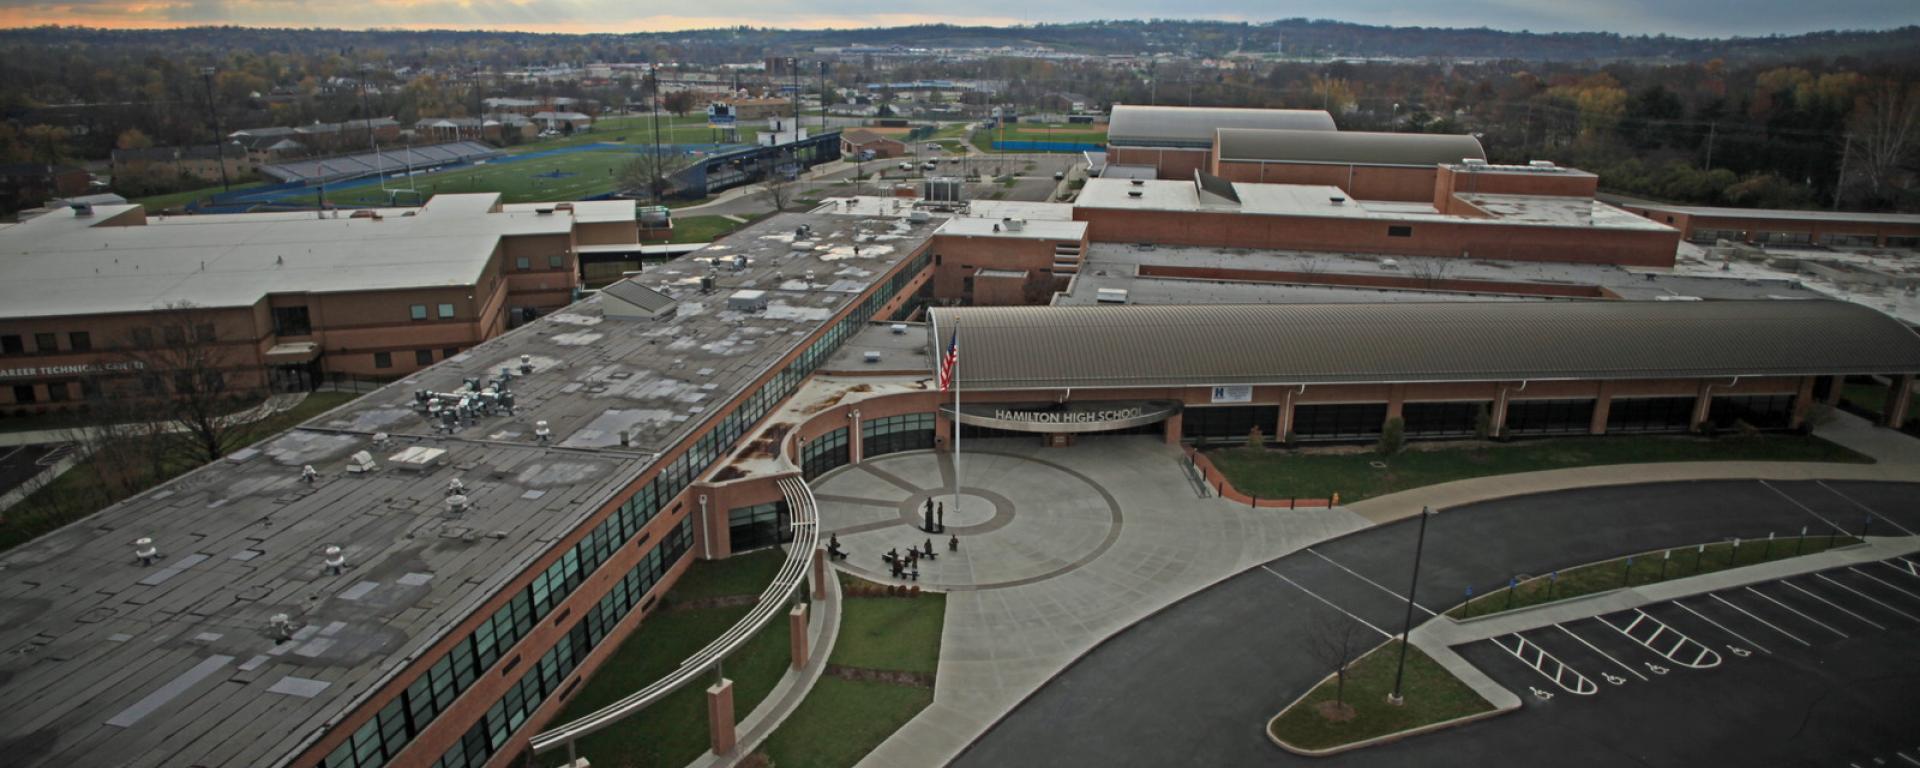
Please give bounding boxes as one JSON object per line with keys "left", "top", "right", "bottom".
{"left": 0, "top": 213, "right": 931, "bottom": 768}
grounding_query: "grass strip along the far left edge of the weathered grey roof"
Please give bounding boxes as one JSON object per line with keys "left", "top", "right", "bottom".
{"left": 0, "top": 392, "right": 357, "bottom": 551}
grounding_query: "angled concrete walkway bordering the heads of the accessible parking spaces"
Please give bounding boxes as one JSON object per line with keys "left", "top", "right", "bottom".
{"left": 1409, "top": 536, "right": 1920, "bottom": 710}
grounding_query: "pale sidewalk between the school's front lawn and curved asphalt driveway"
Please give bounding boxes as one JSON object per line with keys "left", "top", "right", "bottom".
{"left": 1344, "top": 411, "right": 1920, "bottom": 524}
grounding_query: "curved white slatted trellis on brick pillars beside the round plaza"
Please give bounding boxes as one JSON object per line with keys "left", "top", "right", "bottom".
{"left": 532, "top": 476, "right": 820, "bottom": 753}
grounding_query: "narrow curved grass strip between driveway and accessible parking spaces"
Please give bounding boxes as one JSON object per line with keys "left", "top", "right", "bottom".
{"left": 1448, "top": 536, "right": 1860, "bottom": 618}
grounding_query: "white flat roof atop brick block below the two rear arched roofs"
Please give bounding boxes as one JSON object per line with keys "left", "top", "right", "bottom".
{"left": 1077, "top": 179, "right": 1672, "bottom": 230}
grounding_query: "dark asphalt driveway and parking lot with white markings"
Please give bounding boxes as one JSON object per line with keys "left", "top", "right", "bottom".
{"left": 954, "top": 480, "right": 1920, "bottom": 766}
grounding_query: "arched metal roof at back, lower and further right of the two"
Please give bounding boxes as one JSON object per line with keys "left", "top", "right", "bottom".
{"left": 1215, "top": 129, "right": 1486, "bottom": 167}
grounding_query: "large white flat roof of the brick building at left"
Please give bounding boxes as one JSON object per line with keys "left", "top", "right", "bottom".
{"left": 0, "top": 194, "right": 634, "bottom": 319}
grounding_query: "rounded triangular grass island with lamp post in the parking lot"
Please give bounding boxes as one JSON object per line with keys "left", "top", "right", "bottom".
{"left": 1269, "top": 641, "right": 1494, "bottom": 749}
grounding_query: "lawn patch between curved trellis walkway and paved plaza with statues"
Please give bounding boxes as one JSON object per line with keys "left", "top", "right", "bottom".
{"left": 760, "top": 576, "right": 947, "bottom": 768}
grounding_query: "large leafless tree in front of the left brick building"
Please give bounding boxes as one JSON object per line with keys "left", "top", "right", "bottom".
{"left": 121, "top": 301, "right": 265, "bottom": 461}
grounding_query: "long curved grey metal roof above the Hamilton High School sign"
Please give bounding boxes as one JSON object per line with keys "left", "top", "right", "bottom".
{"left": 929, "top": 300, "right": 1920, "bottom": 390}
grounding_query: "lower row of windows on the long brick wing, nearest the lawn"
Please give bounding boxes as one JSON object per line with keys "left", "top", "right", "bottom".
{"left": 434, "top": 518, "right": 693, "bottom": 768}
